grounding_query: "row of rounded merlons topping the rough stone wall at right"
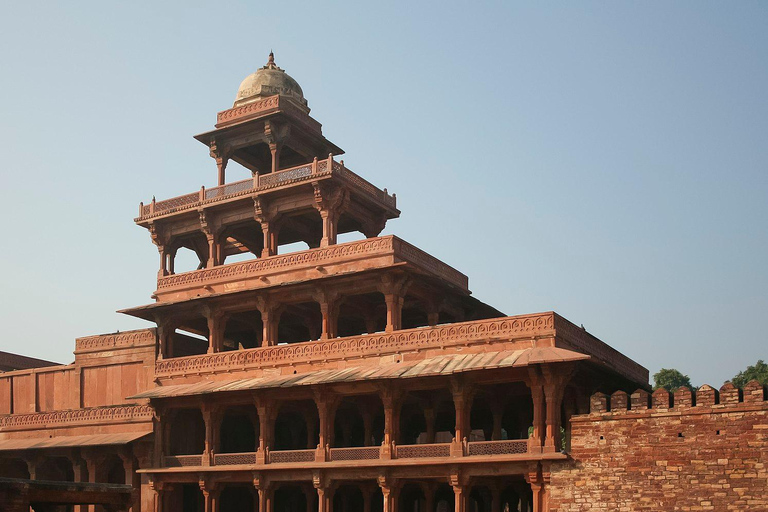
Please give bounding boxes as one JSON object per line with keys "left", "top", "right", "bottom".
{"left": 589, "top": 380, "right": 766, "bottom": 415}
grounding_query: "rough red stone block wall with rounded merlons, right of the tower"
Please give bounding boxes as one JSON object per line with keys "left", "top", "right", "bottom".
{"left": 550, "top": 381, "right": 768, "bottom": 512}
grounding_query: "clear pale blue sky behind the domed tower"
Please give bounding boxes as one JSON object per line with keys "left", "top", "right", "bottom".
{"left": 0, "top": 1, "right": 768, "bottom": 386}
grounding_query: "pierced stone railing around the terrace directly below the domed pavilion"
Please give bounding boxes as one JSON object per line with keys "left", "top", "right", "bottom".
{"left": 136, "top": 160, "right": 397, "bottom": 220}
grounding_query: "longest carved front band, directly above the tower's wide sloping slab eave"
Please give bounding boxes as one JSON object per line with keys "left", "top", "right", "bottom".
{"left": 155, "top": 313, "right": 554, "bottom": 377}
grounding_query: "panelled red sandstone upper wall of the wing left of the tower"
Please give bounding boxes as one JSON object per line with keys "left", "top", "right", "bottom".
{"left": 0, "top": 329, "right": 155, "bottom": 415}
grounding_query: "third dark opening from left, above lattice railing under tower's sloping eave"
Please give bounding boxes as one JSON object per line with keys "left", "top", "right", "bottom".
{"left": 274, "top": 400, "right": 320, "bottom": 450}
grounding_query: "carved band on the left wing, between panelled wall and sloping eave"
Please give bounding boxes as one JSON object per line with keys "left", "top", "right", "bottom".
{"left": 0, "top": 405, "right": 152, "bottom": 430}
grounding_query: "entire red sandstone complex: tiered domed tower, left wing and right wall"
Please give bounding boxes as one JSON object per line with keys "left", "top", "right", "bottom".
{"left": 0, "top": 55, "right": 768, "bottom": 512}
